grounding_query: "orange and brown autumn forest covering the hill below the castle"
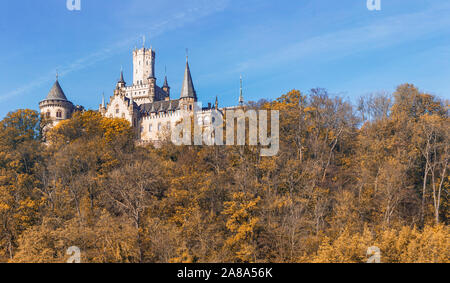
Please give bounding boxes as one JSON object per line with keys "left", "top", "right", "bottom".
{"left": 0, "top": 84, "right": 450, "bottom": 263}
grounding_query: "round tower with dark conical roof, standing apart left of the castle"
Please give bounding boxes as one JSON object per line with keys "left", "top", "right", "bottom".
{"left": 39, "top": 75, "right": 75, "bottom": 125}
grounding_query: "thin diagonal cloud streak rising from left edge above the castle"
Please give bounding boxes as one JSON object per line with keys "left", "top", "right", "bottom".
{"left": 0, "top": 0, "right": 230, "bottom": 101}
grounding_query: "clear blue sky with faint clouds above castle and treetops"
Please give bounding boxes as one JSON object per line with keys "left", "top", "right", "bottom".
{"left": 0, "top": 0, "right": 450, "bottom": 117}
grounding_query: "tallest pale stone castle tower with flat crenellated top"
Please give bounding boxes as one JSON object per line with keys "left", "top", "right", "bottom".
{"left": 133, "top": 40, "right": 155, "bottom": 85}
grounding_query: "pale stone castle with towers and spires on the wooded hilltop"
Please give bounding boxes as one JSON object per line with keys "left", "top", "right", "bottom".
{"left": 39, "top": 42, "right": 244, "bottom": 143}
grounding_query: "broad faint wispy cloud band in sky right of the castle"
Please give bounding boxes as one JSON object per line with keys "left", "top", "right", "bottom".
{"left": 234, "top": 4, "right": 450, "bottom": 72}
